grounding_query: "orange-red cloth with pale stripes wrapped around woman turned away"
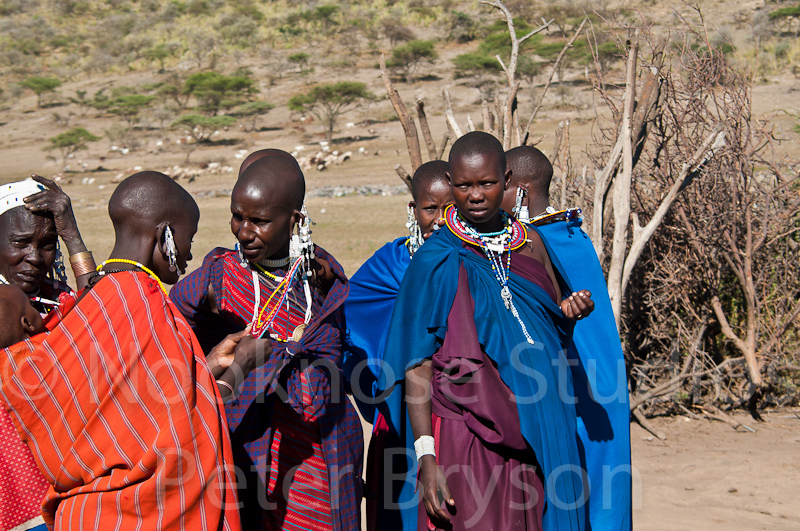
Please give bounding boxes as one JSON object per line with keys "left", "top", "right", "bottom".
{"left": 0, "top": 272, "right": 241, "bottom": 531}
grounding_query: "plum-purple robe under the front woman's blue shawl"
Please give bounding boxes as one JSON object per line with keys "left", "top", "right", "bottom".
{"left": 424, "top": 249, "right": 556, "bottom": 531}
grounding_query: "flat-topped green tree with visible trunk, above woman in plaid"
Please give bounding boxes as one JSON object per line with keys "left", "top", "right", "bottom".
{"left": 288, "top": 81, "right": 375, "bottom": 142}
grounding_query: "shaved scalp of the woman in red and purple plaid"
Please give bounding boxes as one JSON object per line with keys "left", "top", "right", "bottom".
{"left": 233, "top": 149, "right": 306, "bottom": 210}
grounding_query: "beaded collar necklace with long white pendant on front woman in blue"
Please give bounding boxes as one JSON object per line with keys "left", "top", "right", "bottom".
{"left": 445, "top": 206, "right": 534, "bottom": 345}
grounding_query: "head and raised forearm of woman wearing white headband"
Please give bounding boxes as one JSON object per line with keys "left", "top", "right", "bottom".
{"left": 0, "top": 175, "right": 95, "bottom": 312}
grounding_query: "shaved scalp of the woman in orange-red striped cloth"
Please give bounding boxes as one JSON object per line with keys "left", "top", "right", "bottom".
{"left": 108, "top": 171, "right": 200, "bottom": 234}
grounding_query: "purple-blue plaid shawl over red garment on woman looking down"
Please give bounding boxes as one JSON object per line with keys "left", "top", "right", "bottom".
{"left": 170, "top": 247, "right": 364, "bottom": 531}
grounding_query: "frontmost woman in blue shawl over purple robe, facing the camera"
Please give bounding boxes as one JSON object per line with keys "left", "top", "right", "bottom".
{"left": 377, "top": 132, "right": 593, "bottom": 531}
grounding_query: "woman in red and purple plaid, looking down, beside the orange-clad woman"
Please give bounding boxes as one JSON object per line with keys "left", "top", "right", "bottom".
{"left": 175, "top": 149, "right": 364, "bottom": 531}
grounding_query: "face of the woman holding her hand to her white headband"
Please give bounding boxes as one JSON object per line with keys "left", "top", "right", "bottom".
{"left": 0, "top": 207, "right": 58, "bottom": 295}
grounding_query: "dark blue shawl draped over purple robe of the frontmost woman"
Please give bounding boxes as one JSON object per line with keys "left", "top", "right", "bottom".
{"left": 377, "top": 229, "right": 584, "bottom": 531}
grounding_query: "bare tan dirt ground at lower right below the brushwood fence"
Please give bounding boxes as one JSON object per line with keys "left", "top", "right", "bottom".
{"left": 631, "top": 411, "right": 800, "bottom": 531}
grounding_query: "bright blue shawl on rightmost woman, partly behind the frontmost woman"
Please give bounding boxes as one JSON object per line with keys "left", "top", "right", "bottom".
{"left": 537, "top": 219, "right": 631, "bottom": 531}
